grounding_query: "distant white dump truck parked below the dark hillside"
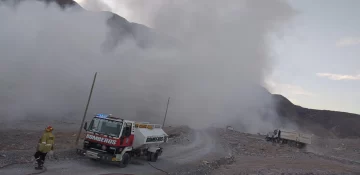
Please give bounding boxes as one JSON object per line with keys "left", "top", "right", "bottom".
{"left": 265, "top": 129, "right": 312, "bottom": 148}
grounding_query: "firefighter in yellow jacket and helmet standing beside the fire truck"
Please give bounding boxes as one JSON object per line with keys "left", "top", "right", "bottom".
{"left": 34, "top": 126, "right": 55, "bottom": 170}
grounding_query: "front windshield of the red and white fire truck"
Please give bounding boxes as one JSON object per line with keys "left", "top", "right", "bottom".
{"left": 89, "top": 118, "right": 122, "bottom": 137}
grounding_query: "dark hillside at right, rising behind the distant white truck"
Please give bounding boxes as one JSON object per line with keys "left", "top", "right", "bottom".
{"left": 273, "top": 94, "right": 360, "bottom": 138}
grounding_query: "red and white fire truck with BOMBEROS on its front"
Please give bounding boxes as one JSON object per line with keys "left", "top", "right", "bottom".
{"left": 77, "top": 114, "right": 168, "bottom": 167}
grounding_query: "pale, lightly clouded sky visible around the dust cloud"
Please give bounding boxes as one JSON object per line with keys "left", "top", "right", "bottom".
{"left": 77, "top": 0, "right": 360, "bottom": 114}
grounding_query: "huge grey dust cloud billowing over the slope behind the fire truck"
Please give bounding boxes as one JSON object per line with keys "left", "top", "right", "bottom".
{"left": 0, "top": 0, "right": 295, "bottom": 133}
